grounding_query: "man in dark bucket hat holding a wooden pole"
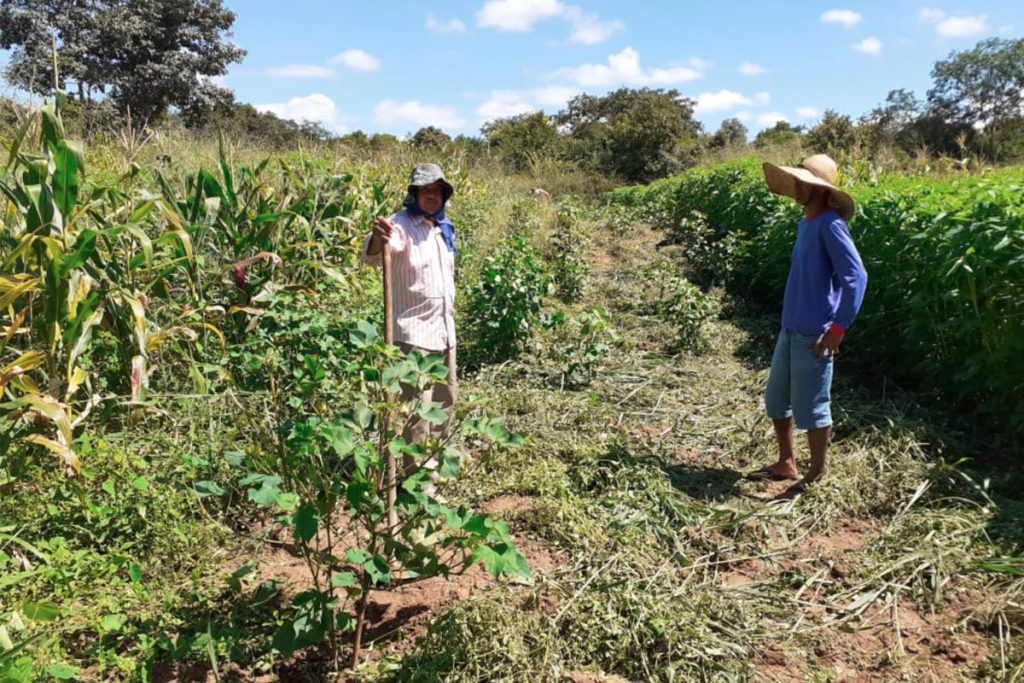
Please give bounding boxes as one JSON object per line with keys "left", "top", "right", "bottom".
{"left": 362, "top": 164, "right": 459, "bottom": 474}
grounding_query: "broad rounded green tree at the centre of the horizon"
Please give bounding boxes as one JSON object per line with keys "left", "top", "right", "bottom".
{"left": 558, "top": 88, "right": 702, "bottom": 182}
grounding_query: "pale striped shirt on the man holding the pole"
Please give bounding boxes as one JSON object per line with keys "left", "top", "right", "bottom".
{"left": 362, "top": 211, "right": 456, "bottom": 351}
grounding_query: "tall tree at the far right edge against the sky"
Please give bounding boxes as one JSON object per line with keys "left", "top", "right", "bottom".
{"left": 928, "top": 38, "right": 1024, "bottom": 155}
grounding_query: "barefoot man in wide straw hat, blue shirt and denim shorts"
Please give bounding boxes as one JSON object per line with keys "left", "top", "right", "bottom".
{"left": 748, "top": 155, "right": 867, "bottom": 498}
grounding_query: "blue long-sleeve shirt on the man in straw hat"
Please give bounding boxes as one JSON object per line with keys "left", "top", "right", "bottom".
{"left": 782, "top": 209, "right": 867, "bottom": 335}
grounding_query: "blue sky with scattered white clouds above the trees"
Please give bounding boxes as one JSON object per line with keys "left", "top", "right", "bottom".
{"left": 6, "top": 0, "right": 1024, "bottom": 135}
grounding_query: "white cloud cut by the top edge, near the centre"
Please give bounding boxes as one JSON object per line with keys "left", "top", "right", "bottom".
{"left": 476, "top": 0, "right": 626, "bottom": 45}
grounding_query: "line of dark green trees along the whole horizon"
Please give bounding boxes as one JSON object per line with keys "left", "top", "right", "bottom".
{"left": 0, "top": 0, "right": 1024, "bottom": 182}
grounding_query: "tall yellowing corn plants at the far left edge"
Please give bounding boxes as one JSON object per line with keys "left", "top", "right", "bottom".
{"left": 0, "top": 95, "right": 209, "bottom": 471}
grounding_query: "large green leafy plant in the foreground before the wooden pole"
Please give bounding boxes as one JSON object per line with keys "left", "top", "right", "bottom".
{"left": 222, "top": 321, "right": 528, "bottom": 666}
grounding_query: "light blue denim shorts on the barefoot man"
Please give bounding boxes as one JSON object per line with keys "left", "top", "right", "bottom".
{"left": 765, "top": 330, "right": 833, "bottom": 429}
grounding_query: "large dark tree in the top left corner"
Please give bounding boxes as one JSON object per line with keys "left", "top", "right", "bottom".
{"left": 0, "top": 0, "right": 245, "bottom": 122}
